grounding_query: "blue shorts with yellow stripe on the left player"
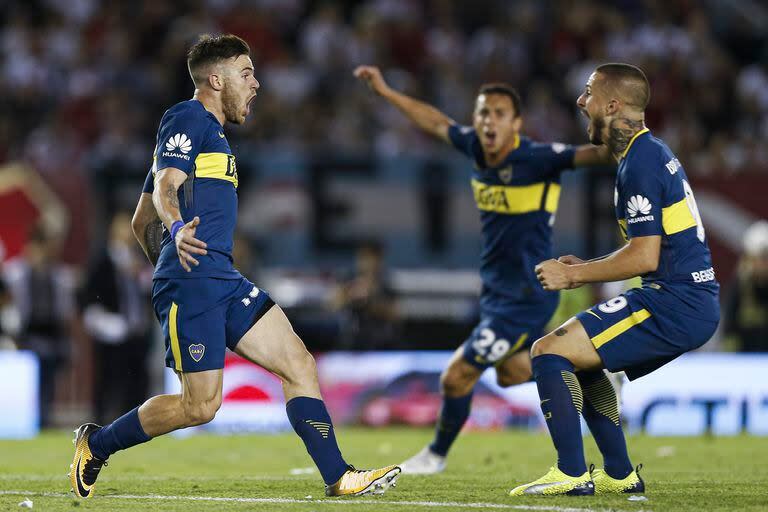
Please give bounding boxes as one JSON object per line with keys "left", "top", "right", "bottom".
{"left": 152, "top": 277, "right": 274, "bottom": 372}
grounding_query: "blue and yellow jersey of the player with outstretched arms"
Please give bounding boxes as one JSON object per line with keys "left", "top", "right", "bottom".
{"left": 448, "top": 125, "right": 575, "bottom": 315}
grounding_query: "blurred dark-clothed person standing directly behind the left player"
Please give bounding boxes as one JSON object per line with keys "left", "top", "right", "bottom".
{"left": 82, "top": 212, "right": 153, "bottom": 423}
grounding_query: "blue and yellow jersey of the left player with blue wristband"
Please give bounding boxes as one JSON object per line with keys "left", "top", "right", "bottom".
{"left": 144, "top": 100, "right": 242, "bottom": 279}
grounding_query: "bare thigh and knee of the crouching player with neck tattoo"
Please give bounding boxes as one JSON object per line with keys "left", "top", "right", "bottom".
{"left": 531, "top": 317, "right": 603, "bottom": 370}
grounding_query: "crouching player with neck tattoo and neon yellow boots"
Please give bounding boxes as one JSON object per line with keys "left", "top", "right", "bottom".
{"left": 510, "top": 64, "right": 720, "bottom": 495}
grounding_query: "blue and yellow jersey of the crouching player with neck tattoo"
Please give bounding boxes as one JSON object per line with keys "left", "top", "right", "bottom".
{"left": 614, "top": 128, "right": 719, "bottom": 307}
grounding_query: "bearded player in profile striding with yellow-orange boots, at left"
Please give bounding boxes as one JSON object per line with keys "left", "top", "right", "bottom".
{"left": 70, "top": 35, "right": 400, "bottom": 498}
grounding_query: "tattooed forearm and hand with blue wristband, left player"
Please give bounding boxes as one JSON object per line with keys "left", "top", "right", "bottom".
{"left": 152, "top": 167, "right": 208, "bottom": 272}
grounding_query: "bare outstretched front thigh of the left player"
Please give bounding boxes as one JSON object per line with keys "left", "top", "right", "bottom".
{"left": 235, "top": 304, "right": 316, "bottom": 382}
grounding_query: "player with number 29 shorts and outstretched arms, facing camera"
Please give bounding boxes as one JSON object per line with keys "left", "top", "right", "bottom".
{"left": 354, "top": 66, "right": 610, "bottom": 474}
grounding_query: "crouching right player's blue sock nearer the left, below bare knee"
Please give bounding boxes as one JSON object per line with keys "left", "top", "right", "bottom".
{"left": 531, "top": 354, "right": 587, "bottom": 476}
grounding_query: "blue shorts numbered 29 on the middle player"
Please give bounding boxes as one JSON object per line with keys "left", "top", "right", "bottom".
{"left": 463, "top": 301, "right": 557, "bottom": 370}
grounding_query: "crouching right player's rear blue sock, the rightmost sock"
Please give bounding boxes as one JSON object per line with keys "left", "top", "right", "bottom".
{"left": 576, "top": 370, "right": 632, "bottom": 480}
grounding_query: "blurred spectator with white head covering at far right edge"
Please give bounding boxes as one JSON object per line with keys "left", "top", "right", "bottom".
{"left": 725, "top": 220, "right": 768, "bottom": 352}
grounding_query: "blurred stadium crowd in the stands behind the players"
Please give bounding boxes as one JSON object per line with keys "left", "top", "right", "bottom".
{"left": 0, "top": 0, "right": 768, "bottom": 176}
